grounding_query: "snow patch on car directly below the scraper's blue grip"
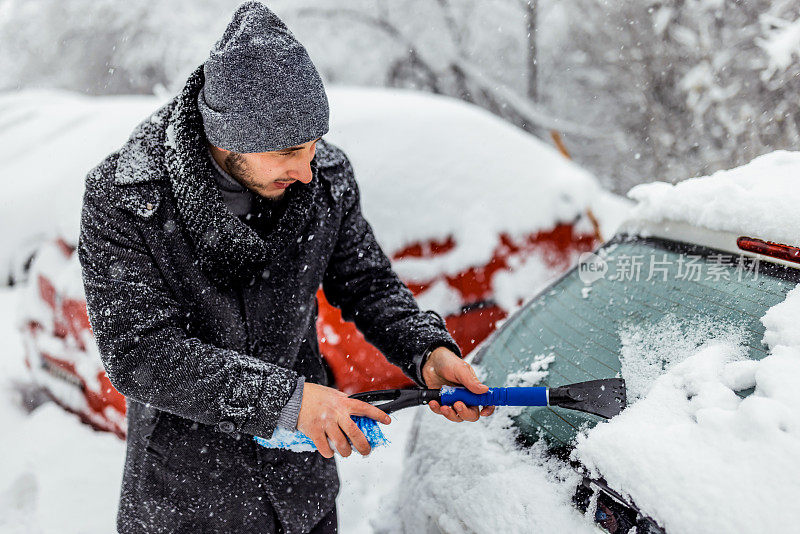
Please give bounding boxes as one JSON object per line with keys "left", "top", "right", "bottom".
{"left": 373, "top": 408, "right": 597, "bottom": 534}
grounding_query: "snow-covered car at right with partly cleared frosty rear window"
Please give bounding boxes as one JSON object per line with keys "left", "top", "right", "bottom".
{"left": 386, "top": 152, "right": 800, "bottom": 532}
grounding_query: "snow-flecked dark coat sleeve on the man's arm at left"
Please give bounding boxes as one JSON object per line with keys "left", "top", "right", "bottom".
{"left": 78, "top": 163, "right": 298, "bottom": 436}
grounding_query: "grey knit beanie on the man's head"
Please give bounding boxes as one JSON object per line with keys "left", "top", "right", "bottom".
{"left": 197, "top": 0, "right": 329, "bottom": 153}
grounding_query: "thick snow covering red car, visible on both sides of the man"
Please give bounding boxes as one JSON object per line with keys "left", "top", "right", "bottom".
{"left": 0, "top": 87, "right": 608, "bottom": 282}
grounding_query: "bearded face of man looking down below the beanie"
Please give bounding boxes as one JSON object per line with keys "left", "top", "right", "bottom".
{"left": 210, "top": 139, "right": 318, "bottom": 200}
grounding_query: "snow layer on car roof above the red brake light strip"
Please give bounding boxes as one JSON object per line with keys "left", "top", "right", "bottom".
{"left": 628, "top": 150, "right": 800, "bottom": 245}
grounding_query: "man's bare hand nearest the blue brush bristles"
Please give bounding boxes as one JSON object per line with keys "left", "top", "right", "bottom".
{"left": 297, "top": 382, "right": 391, "bottom": 458}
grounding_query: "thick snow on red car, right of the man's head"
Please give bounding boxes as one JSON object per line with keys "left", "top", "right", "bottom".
{"left": 329, "top": 88, "right": 601, "bottom": 278}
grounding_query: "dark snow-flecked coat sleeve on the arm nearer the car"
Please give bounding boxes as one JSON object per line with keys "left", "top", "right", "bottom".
{"left": 322, "top": 158, "right": 461, "bottom": 386}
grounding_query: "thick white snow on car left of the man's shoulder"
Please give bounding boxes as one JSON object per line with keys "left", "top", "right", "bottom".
{"left": 0, "top": 90, "right": 160, "bottom": 278}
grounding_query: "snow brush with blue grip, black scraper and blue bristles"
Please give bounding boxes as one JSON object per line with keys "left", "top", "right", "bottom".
{"left": 254, "top": 378, "right": 627, "bottom": 452}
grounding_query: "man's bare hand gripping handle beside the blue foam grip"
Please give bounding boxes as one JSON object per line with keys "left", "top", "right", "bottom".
{"left": 422, "top": 347, "right": 494, "bottom": 423}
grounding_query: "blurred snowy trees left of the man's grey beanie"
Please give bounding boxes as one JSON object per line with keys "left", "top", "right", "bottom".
{"left": 0, "top": 0, "right": 240, "bottom": 94}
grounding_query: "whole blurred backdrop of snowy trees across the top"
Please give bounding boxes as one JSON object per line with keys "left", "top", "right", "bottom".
{"left": 0, "top": 0, "right": 800, "bottom": 192}
